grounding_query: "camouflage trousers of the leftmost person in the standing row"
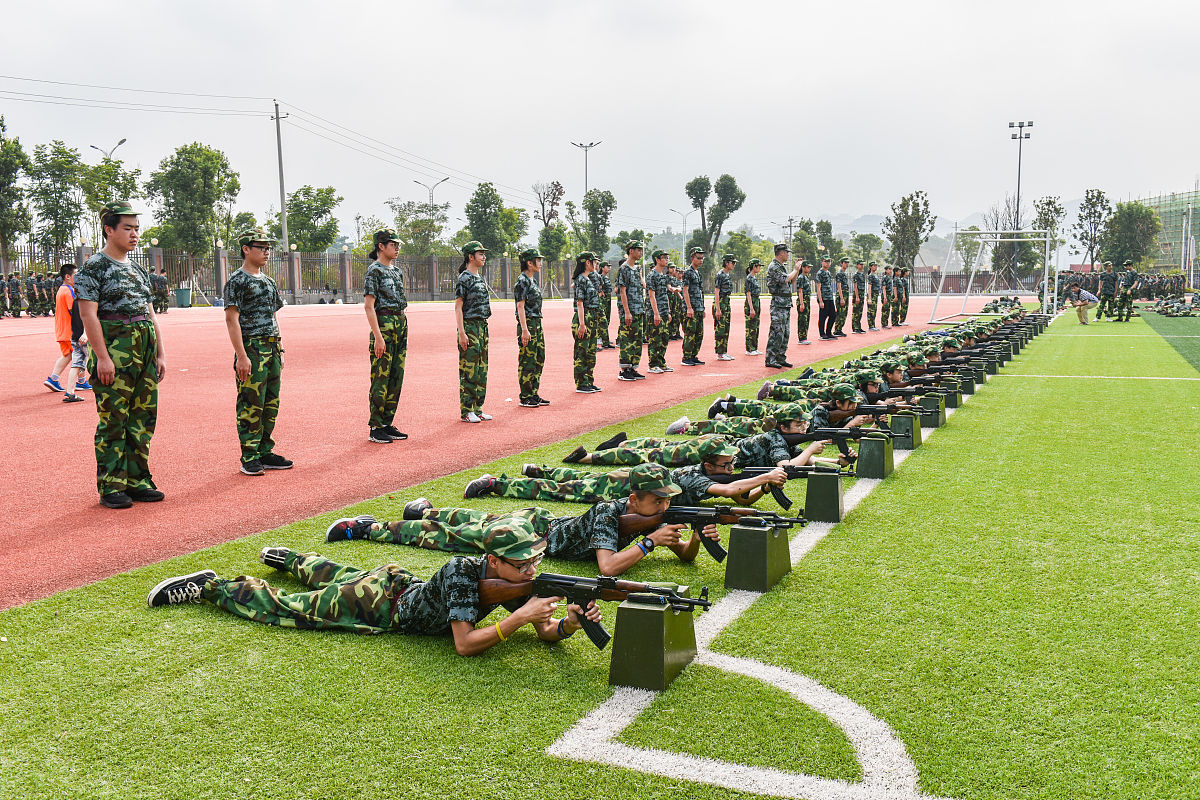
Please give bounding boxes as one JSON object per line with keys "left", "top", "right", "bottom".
{"left": 88, "top": 320, "right": 158, "bottom": 494}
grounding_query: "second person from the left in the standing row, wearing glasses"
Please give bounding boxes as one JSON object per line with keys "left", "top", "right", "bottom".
{"left": 222, "top": 228, "right": 292, "bottom": 475}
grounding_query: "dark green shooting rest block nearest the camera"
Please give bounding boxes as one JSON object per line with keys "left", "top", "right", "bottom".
{"left": 608, "top": 587, "right": 700, "bottom": 692}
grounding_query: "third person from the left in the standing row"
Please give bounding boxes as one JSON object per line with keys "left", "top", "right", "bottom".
{"left": 362, "top": 228, "right": 408, "bottom": 444}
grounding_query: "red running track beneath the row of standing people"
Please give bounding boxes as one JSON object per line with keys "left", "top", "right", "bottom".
{"left": 0, "top": 297, "right": 986, "bottom": 608}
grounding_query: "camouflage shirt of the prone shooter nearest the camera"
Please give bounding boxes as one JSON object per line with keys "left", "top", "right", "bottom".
{"left": 392, "top": 555, "right": 527, "bottom": 636}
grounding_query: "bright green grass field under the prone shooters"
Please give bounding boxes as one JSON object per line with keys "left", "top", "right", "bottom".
{"left": 0, "top": 317, "right": 1200, "bottom": 800}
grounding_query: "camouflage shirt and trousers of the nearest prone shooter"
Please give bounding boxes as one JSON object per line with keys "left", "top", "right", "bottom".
{"left": 200, "top": 551, "right": 526, "bottom": 636}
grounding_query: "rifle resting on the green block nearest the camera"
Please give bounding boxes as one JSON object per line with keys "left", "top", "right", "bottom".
{"left": 479, "top": 572, "right": 713, "bottom": 650}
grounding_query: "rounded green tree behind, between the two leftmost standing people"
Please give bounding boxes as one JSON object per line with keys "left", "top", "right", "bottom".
{"left": 146, "top": 142, "right": 238, "bottom": 255}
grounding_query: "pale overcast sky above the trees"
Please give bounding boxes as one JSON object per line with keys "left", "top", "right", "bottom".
{"left": 0, "top": 0, "right": 1200, "bottom": 241}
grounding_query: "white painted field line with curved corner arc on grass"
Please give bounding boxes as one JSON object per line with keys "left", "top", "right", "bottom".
{"left": 546, "top": 393, "right": 969, "bottom": 800}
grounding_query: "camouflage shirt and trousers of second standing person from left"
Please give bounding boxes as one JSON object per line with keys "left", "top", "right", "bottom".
{"left": 223, "top": 269, "right": 283, "bottom": 464}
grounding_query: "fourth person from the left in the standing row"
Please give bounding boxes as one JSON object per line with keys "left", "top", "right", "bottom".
{"left": 454, "top": 241, "right": 492, "bottom": 422}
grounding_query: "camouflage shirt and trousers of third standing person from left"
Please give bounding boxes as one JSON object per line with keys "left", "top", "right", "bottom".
{"left": 362, "top": 261, "right": 408, "bottom": 429}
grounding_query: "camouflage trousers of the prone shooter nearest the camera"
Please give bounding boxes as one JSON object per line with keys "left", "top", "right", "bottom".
{"left": 200, "top": 551, "right": 416, "bottom": 633}
